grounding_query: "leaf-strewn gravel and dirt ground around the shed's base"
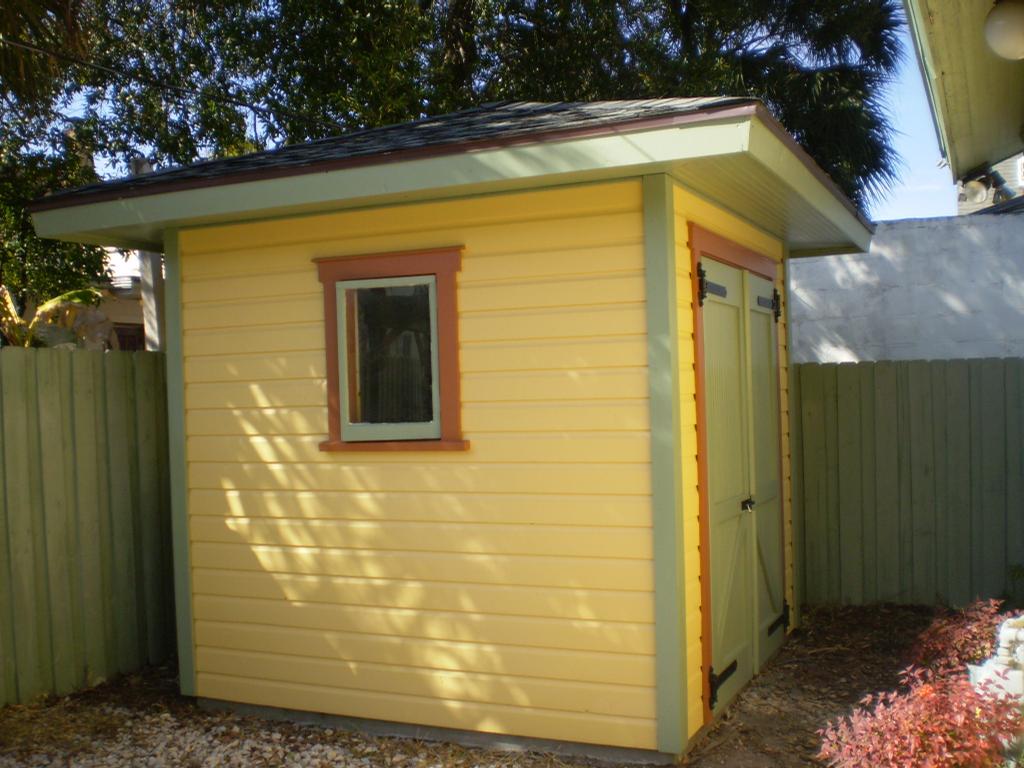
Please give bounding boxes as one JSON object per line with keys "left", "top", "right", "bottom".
{"left": 0, "top": 606, "right": 931, "bottom": 768}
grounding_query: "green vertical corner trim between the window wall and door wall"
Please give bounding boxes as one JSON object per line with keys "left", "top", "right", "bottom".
{"left": 643, "top": 174, "right": 687, "bottom": 755}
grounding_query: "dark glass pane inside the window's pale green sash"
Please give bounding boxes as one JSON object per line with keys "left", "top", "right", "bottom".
{"left": 345, "top": 282, "right": 434, "bottom": 424}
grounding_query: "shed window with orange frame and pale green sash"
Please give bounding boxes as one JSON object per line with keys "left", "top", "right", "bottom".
{"left": 316, "top": 248, "right": 468, "bottom": 451}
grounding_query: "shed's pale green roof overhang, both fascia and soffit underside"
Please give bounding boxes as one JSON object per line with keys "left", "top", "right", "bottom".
{"left": 33, "top": 104, "right": 871, "bottom": 255}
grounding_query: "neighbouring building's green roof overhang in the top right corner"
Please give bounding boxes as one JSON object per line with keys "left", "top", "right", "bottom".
{"left": 905, "top": 0, "right": 1024, "bottom": 179}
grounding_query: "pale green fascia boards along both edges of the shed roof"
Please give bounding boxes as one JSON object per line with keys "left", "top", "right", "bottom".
{"left": 33, "top": 104, "right": 870, "bottom": 250}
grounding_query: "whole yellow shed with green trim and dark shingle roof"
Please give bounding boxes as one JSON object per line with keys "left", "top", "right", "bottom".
{"left": 34, "top": 98, "right": 870, "bottom": 755}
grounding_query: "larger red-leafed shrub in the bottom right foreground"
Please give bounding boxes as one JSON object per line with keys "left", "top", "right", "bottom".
{"left": 818, "top": 669, "right": 1024, "bottom": 768}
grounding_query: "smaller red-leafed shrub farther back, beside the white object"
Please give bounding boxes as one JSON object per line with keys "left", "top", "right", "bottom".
{"left": 912, "top": 600, "right": 1011, "bottom": 674}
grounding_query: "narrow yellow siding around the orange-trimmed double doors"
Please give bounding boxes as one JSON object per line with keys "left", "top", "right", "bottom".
{"left": 674, "top": 185, "right": 793, "bottom": 735}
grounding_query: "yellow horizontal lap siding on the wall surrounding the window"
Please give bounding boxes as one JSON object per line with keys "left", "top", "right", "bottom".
{"left": 180, "top": 182, "right": 655, "bottom": 749}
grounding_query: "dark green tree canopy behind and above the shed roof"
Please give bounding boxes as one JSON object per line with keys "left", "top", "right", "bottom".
{"left": 6, "top": 0, "right": 902, "bottom": 282}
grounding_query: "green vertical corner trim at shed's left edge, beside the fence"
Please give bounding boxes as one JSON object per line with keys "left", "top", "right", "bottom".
{"left": 164, "top": 229, "right": 196, "bottom": 696}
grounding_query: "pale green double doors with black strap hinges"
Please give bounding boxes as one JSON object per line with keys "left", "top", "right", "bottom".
{"left": 701, "top": 258, "right": 787, "bottom": 712}
